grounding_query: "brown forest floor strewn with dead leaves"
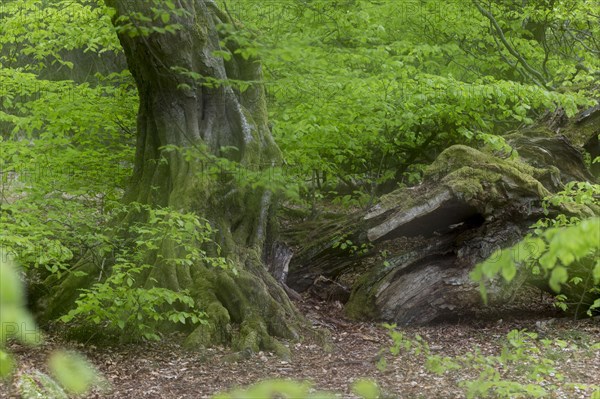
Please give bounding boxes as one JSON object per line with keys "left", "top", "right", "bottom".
{"left": 0, "top": 300, "right": 600, "bottom": 398}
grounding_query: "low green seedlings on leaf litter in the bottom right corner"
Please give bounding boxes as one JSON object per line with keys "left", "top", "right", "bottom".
{"left": 378, "top": 325, "right": 600, "bottom": 399}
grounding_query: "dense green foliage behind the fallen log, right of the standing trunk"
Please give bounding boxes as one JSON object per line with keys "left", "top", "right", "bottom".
{"left": 227, "top": 0, "right": 600, "bottom": 202}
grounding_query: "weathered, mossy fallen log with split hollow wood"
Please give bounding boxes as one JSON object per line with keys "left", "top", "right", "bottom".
{"left": 287, "top": 108, "right": 598, "bottom": 324}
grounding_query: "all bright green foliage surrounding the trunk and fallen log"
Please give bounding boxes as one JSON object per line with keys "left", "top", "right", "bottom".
{"left": 0, "top": 0, "right": 600, "bottom": 398}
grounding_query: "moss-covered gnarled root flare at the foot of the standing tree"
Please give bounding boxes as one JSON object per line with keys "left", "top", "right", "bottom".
{"left": 186, "top": 253, "right": 302, "bottom": 357}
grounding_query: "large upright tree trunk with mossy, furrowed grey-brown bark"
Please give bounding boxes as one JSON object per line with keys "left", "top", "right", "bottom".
{"left": 43, "top": 0, "right": 298, "bottom": 350}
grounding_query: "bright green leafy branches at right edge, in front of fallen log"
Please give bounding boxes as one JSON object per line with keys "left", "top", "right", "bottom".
{"left": 471, "top": 183, "right": 600, "bottom": 316}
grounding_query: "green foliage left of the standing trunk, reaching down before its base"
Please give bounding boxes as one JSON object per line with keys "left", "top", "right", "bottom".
{"left": 0, "top": 1, "right": 211, "bottom": 339}
